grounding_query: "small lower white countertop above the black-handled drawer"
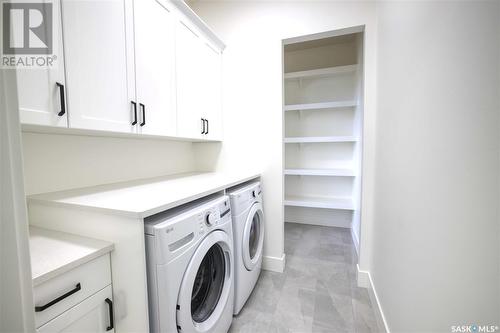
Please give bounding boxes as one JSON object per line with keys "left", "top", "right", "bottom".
{"left": 30, "top": 226, "right": 114, "bottom": 286}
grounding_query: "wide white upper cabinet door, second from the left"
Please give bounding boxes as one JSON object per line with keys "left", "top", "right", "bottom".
{"left": 61, "top": 0, "right": 135, "bottom": 132}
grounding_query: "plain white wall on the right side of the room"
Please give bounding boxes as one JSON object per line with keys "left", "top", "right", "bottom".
{"left": 371, "top": 2, "right": 500, "bottom": 332}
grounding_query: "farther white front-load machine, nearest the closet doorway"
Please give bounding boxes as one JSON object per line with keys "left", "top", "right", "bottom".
{"left": 229, "top": 182, "right": 264, "bottom": 315}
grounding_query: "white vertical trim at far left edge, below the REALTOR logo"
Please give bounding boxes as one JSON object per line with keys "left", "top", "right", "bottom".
{"left": 0, "top": 65, "right": 35, "bottom": 332}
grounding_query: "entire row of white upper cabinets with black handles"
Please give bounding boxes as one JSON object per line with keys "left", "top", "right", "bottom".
{"left": 18, "top": 0, "right": 224, "bottom": 140}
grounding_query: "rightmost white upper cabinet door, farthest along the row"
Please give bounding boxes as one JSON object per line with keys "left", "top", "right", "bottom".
{"left": 201, "top": 43, "right": 222, "bottom": 140}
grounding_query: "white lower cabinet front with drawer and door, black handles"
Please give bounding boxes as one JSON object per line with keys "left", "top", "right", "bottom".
{"left": 33, "top": 254, "right": 114, "bottom": 332}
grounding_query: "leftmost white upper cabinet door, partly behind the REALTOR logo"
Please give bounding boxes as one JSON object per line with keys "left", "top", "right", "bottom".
{"left": 16, "top": 0, "right": 68, "bottom": 127}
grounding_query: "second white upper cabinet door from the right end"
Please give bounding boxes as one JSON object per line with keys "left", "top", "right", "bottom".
{"left": 175, "top": 21, "right": 202, "bottom": 138}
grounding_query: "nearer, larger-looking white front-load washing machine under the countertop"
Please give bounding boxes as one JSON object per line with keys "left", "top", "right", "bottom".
{"left": 145, "top": 196, "right": 234, "bottom": 333}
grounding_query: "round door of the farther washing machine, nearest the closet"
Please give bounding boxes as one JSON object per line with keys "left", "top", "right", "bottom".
{"left": 241, "top": 202, "right": 264, "bottom": 271}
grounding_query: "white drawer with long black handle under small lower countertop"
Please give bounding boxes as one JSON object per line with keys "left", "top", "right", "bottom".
{"left": 33, "top": 254, "right": 111, "bottom": 327}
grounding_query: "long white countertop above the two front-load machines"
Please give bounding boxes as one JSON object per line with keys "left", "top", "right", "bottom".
{"left": 28, "top": 173, "right": 260, "bottom": 218}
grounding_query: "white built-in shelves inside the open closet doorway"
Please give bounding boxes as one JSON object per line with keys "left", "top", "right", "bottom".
{"left": 283, "top": 33, "right": 363, "bottom": 245}
